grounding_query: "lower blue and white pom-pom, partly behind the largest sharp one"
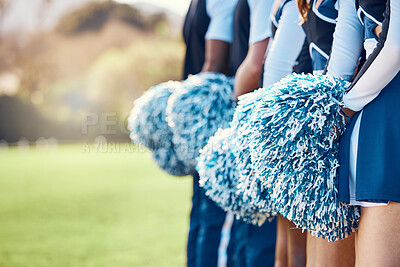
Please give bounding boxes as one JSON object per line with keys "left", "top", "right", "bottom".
{"left": 197, "top": 89, "right": 276, "bottom": 225}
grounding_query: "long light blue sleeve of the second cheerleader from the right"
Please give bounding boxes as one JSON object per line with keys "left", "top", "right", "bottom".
{"left": 327, "top": 0, "right": 363, "bottom": 81}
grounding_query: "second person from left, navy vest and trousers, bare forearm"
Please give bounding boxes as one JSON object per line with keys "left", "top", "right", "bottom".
{"left": 231, "top": 0, "right": 276, "bottom": 267}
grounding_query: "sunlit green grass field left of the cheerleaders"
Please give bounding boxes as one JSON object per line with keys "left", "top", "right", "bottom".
{"left": 0, "top": 144, "right": 191, "bottom": 267}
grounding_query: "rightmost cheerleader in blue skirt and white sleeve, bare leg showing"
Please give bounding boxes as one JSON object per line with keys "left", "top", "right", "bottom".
{"left": 339, "top": 0, "right": 400, "bottom": 266}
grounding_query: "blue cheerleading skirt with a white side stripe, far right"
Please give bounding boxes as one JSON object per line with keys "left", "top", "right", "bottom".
{"left": 339, "top": 72, "right": 400, "bottom": 206}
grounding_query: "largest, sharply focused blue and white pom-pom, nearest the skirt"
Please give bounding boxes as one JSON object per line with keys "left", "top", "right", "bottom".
{"left": 249, "top": 74, "right": 360, "bottom": 241}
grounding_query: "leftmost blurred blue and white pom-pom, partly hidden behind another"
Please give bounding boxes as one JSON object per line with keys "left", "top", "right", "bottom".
{"left": 128, "top": 81, "right": 191, "bottom": 176}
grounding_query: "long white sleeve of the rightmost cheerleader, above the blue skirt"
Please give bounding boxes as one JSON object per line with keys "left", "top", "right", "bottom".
{"left": 343, "top": 0, "right": 400, "bottom": 111}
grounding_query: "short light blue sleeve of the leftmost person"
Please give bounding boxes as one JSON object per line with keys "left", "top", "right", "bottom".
{"left": 205, "top": 0, "right": 238, "bottom": 43}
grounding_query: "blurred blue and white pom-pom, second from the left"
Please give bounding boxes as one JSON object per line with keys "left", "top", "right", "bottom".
{"left": 167, "top": 73, "right": 236, "bottom": 170}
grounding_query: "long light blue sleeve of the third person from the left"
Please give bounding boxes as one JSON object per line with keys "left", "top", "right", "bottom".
{"left": 263, "top": 1, "right": 305, "bottom": 87}
